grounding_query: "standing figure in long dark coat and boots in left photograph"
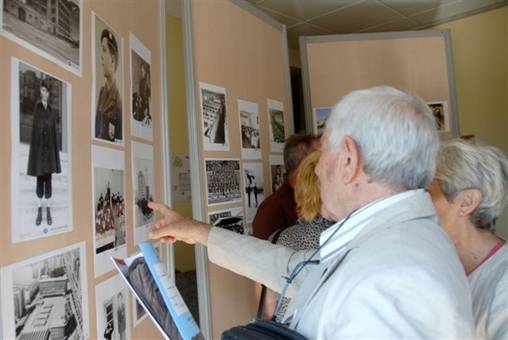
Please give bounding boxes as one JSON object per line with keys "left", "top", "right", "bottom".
{"left": 27, "top": 81, "right": 62, "bottom": 226}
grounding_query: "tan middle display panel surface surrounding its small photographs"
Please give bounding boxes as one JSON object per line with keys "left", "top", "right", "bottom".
{"left": 187, "top": 0, "right": 293, "bottom": 339}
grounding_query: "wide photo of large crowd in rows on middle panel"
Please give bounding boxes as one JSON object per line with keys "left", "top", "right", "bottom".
{"left": 205, "top": 159, "right": 242, "bottom": 205}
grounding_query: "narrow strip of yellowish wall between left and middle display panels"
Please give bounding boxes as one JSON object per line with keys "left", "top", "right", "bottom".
{"left": 167, "top": 16, "right": 196, "bottom": 272}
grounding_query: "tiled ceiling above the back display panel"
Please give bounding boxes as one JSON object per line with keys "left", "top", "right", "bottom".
{"left": 167, "top": 0, "right": 508, "bottom": 49}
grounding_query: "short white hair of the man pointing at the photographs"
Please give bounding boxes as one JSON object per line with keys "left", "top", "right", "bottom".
{"left": 326, "top": 86, "right": 439, "bottom": 190}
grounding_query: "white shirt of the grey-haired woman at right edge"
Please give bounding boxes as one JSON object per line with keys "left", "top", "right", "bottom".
{"left": 468, "top": 243, "right": 508, "bottom": 339}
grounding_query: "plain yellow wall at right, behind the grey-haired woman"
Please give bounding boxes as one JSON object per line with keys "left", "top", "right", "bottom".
{"left": 434, "top": 7, "right": 508, "bottom": 238}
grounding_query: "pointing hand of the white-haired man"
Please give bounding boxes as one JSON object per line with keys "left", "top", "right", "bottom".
{"left": 148, "top": 202, "right": 211, "bottom": 245}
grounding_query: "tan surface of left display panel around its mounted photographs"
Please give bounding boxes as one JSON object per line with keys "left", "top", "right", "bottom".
{"left": 0, "top": 0, "right": 164, "bottom": 339}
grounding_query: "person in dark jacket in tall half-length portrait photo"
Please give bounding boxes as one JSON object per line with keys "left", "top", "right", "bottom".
{"left": 95, "top": 28, "right": 122, "bottom": 142}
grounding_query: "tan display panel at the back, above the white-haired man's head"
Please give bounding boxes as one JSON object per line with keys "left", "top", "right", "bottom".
{"left": 300, "top": 31, "right": 458, "bottom": 138}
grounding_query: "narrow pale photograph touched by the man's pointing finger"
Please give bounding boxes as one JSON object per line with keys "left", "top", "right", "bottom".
{"left": 131, "top": 142, "right": 155, "bottom": 244}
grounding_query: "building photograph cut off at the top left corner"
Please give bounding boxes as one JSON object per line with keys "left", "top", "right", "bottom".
{"left": 0, "top": 0, "right": 83, "bottom": 76}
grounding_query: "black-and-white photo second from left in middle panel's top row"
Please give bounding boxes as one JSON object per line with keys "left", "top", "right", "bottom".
{"left": 238, "top": 99, "right": 261, "bottom": 160}
